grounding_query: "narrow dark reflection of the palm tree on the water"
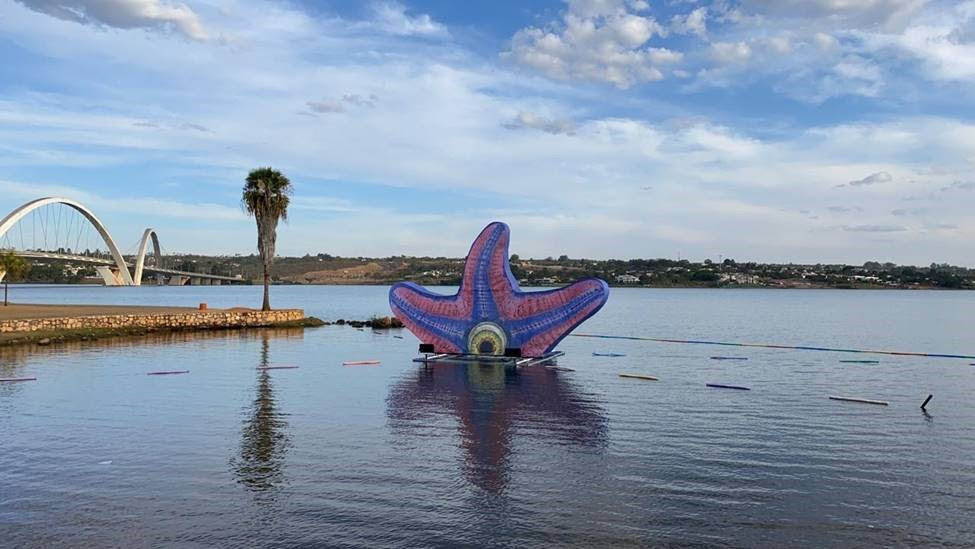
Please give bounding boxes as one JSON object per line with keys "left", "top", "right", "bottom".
{"left": 232, "top": 335, "right": 289, "bottom": 493}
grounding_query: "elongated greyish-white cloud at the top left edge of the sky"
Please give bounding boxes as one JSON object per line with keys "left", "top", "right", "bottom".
{"left": 16, "top": 0, "right": 208, "bottom": 40}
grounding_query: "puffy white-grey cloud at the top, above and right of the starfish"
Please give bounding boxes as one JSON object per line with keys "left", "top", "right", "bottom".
{"left": 502, "top": 0, "right": 682, "bottom": 88}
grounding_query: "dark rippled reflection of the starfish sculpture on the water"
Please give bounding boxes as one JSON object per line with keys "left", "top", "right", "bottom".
{"left": 387, "top": 364, "right": 607, "bottom": 493}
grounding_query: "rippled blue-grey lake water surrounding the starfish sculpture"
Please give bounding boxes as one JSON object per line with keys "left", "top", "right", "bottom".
{"left": 0, "top": 286, "right": 975, "bottom": 547}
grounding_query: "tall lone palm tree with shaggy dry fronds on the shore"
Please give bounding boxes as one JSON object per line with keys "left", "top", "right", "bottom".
{"left": 240, "top": 168, "right": 291, "bottom": 311}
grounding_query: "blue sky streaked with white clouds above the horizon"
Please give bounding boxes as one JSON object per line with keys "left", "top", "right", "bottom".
{"left": 0, "top": 0, "right": 975, "bottom": 266}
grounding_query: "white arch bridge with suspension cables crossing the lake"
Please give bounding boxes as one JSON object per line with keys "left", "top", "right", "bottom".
{"left": 0, "top": 197, "right": 245, "bottom": 286}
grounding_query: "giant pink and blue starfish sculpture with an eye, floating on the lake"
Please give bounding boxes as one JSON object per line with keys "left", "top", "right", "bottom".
{"left": 389, "top": 222, "right": 609, "bottom": 357}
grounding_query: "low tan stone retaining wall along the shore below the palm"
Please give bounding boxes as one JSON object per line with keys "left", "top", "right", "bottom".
{"left": 0, "top": 309, "right": 305, "bottom": 334}
